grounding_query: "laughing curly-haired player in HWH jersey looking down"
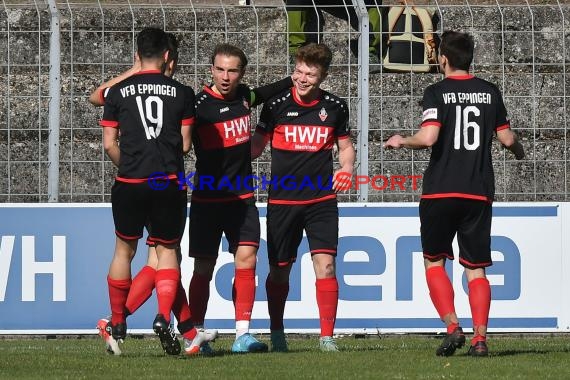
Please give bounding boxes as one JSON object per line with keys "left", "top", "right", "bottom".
{"left": 252, "top": 44, "right": 355, "bottom": 351}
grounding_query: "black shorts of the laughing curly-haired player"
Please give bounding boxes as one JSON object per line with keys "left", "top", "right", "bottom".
{"left": 267, "top": 199, "right": 338, "bottom": 265}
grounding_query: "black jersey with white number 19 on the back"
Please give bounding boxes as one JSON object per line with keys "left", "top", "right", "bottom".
{"left": 100, "top": 70, "right": 195, "bottom": 182}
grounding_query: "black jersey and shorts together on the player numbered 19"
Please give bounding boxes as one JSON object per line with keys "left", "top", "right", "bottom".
{"left": 100, "top": 70, "right": 195, "bottom": 244}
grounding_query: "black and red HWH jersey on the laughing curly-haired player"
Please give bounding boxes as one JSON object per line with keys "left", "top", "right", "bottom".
{"left": 257, "top": 87, "right": 350, "bottom": 204}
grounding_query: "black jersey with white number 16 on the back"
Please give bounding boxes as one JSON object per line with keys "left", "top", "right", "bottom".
{"left": 422, "top": 75, "right": 510, "bottom": 201}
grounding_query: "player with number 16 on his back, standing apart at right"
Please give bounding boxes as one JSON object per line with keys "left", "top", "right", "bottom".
{"left": 384, "top": 31, "right": 524, "bottom": 356}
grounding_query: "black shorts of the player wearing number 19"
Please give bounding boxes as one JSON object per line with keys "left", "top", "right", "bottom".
{"left": 111, "top": 181, "right": 186, "bottom": 245}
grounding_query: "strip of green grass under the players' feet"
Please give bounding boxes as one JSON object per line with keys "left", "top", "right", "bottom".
{"left": 0, "top": 335, "right": 570, "bottom": 380}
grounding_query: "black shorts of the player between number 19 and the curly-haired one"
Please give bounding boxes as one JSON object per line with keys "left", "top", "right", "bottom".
{"left": 189, "top": 198, "right": 260, "bottom": 257}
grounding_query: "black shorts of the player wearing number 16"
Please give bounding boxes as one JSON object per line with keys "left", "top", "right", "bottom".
{"left": 420, "top": 198, "right": 493, "bottom": 269}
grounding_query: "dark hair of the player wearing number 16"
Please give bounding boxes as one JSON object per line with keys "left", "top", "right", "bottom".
{"left": 439, "top": 30, "right": 475, "bottom": 71}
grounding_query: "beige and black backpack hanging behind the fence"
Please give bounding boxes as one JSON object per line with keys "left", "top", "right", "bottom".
{"left": 383, "top": 4, "right": 438, "bottom": 73}
